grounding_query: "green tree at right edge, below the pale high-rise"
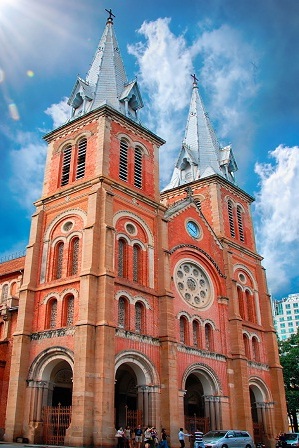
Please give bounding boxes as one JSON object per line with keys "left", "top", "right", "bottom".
{"left": 279, "top": 328, "right": 299, "bottom": 432}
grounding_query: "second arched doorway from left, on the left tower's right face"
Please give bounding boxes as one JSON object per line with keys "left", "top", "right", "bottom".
{"left": 114, "top": 350, "right": 160, "bottom": 427}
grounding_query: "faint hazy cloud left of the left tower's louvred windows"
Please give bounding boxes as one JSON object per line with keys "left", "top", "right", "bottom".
{"left": 9, "top": 132, "right": 47, "bottom": 213}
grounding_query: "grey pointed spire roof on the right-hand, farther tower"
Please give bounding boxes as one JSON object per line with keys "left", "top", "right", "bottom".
{"left": 163, "top": 75, "right": 238, "bottom": 191}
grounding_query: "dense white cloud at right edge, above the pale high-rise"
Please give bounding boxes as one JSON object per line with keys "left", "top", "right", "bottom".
{"left": 255, "top": 145, "right": 299, "bottom": 294}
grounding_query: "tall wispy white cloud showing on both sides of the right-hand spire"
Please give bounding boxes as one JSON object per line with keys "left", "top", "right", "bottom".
{"left": 129, "top": 18, "right": 258, "bottom": 186}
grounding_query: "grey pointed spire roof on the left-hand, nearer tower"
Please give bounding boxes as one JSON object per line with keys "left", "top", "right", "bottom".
{"left": 68, "top": 10, "right": 143, "bottom": 121}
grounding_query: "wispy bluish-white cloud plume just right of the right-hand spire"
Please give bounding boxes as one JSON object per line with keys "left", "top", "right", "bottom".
{"left": 192, "top": 24, "right": 259, "bottom": 159}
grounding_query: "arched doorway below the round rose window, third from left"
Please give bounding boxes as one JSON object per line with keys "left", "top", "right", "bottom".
{"left": 183, "top": 364, "right": 221, "bottom": 432}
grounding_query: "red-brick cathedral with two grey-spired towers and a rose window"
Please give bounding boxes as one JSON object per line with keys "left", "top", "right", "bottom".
{"left": 0, "top": 10, "right": 287, "bottom": 448}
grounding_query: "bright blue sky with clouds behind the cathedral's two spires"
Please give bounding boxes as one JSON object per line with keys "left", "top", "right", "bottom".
{"left": 0, "top": 0, "right": 299, "bottom": 298}
